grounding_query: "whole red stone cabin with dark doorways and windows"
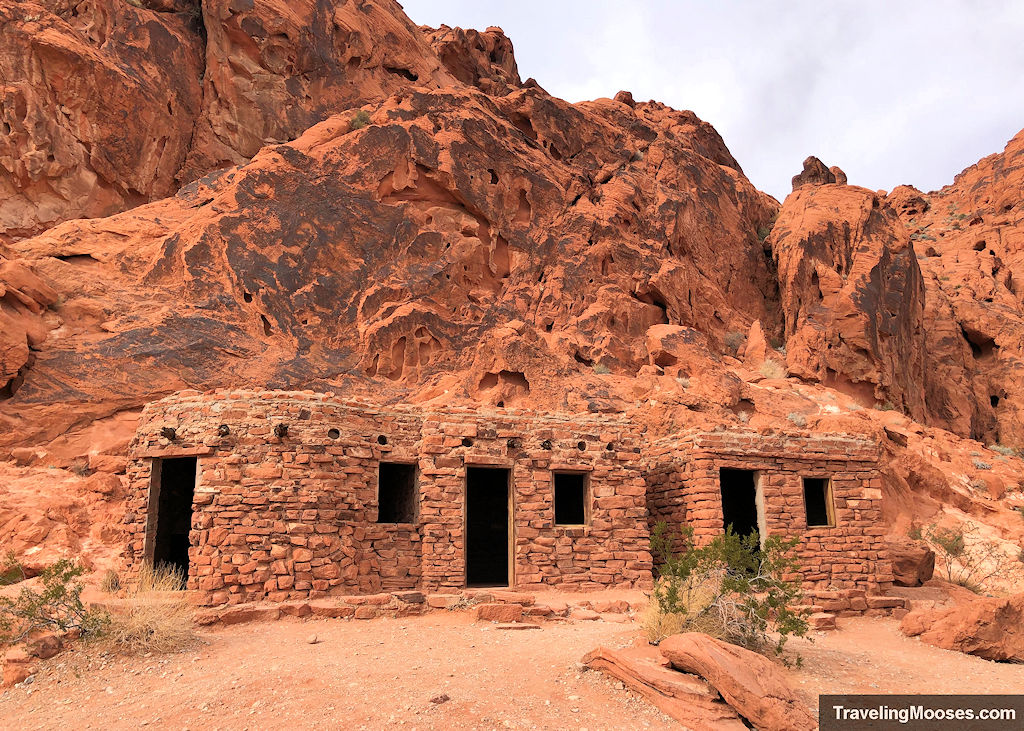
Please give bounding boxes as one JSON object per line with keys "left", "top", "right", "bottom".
{"left": 125, "top": 390, "right": 892, "bottom": 605}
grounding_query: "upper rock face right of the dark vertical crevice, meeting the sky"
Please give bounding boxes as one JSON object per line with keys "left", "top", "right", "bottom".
{"left": 179, "top": 0, "right": 456, "bottom": 182}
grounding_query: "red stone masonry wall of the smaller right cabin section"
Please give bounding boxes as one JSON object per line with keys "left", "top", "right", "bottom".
{"left": 647, "top": 423, "right": 893, "bottom": 593}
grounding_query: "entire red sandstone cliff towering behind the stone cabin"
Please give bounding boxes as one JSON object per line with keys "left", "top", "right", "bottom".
{"left": 0, "top": 0, "right": 1024, "bottom": 573}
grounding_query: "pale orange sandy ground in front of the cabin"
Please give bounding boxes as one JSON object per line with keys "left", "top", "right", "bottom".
{"left": 0, "top": 612, "right": 1024, "bottom": 731}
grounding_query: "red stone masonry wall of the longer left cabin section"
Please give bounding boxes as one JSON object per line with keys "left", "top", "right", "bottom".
{"left": 125, "top": 391, "right": 651, "bottom": 605}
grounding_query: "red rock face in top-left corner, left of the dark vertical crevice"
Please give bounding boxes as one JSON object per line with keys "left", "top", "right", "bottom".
{"left": 0, "top": 0, "right": 203, "bottom": 242}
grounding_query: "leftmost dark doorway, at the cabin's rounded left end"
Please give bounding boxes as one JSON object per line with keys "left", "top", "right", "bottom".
{"left": 150, "top": 457, "right": 197, "bottom": 576}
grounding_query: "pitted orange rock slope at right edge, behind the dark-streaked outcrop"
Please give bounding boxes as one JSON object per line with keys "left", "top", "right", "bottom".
{"left": 889, "top": 132, "right": 1024, "bottom": 446}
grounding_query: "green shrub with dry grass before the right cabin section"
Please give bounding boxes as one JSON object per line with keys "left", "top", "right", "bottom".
{"left": 648, "top": 522, "right": 808, "bottom": 655}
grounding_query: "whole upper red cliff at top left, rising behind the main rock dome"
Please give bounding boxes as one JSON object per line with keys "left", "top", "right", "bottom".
{"left": 0, "top": 0, "right": 468, "bottom": 242}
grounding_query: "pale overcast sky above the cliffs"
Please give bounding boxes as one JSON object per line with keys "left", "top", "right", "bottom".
{"left": 402, "top": 0, "right": 1024, "bottom": 200}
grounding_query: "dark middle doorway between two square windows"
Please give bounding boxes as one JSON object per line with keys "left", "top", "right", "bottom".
{"left": 466, "top": 467, "right": 509, "bottom": 587}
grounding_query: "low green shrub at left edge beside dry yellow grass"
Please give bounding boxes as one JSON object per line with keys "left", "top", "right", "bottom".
{"left": 0, "top": 559, "right": 108, "bottom": 644}
